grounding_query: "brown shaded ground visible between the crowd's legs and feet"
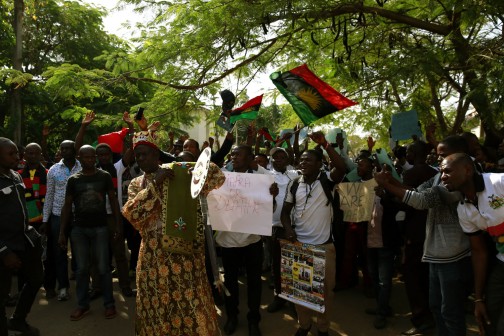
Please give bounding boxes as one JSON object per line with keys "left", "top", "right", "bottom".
{"left": 9, "top": 278, "right": 477, "bottom": 336}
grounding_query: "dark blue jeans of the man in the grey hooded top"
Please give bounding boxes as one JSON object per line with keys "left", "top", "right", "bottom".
{"left": 429, "top": 257, "right": 471, "bottom": 336}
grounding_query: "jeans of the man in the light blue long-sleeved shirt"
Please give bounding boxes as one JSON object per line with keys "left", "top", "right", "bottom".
{"left": 44, "top": 215, "right": 70, "bottom": 291}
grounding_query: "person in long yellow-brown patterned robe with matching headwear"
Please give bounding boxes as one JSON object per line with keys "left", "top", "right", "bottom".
{"left": 123, "top": 132, "right": 225, "bottom": 336}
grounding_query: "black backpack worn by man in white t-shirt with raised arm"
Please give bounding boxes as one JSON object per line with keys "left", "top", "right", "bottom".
{"left": 290, "top": 172, "right": 344, "bottom": 242}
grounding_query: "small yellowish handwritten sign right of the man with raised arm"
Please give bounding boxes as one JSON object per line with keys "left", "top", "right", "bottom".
{"left": 338, "top": 179, "right": 377, "bottom": 222}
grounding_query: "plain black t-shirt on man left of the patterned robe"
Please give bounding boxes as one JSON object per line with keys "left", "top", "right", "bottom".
{"left": 66, "top": 169, "right": 114, "bottom": 227}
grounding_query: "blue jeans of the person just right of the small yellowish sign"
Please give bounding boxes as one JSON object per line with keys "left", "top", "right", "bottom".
{"left": 367, "top": 247, "right": 396, "bottom": 317}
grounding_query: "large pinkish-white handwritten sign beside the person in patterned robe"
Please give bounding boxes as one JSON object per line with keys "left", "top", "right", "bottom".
{"left": 207, "top": 172, "right": 275, "bottom": 236}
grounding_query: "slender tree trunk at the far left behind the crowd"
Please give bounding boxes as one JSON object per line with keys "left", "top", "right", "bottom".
{"left": 10, "top": 0, "right": 24, "bottom": 145}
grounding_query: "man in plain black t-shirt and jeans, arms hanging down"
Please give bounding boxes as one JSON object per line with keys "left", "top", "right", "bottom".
{"left": 59, "top": 145, "right": 120, "bottom": 321}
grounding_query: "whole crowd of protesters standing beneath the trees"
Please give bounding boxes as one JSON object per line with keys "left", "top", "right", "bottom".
{"left": 0, "top": 113, "right": 504, "bottom": 336}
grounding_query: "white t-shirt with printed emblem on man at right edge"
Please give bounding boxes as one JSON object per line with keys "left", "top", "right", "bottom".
{"left": 457, "top": 173, "right": 504, "bottom": 262}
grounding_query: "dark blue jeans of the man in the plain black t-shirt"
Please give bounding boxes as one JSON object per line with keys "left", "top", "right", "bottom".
{"left": 70, "top": 226, "right": 114, "bottom": 309}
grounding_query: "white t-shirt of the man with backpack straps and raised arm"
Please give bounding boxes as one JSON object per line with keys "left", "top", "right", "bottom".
{"left": 285, "top": 172, "right": 334, "bottom": 245}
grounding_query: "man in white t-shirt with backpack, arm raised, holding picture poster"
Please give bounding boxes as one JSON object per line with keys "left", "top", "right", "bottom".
{"left": 281, "top": 133, "right": 345, "bottom": 336}
